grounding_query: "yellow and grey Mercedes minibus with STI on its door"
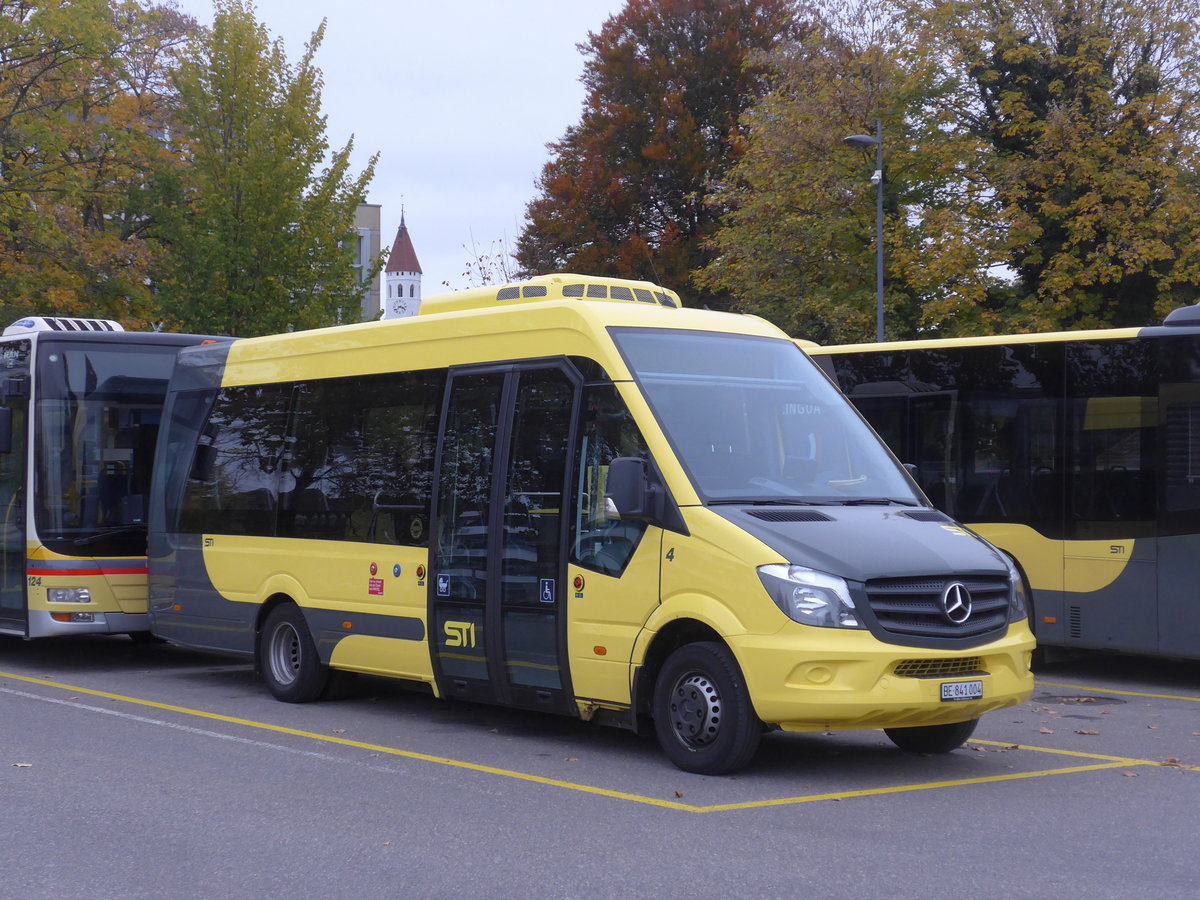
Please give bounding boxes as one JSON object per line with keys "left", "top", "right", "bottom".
{"left": 150, "top": 275, "right": 1033, "bottom": 774}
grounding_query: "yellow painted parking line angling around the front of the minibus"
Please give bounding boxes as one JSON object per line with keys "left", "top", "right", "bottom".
{"left": 0, "top": 672, "right": 1160, "bottom": 812}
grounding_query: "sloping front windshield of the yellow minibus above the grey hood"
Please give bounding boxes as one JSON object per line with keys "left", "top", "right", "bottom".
{"left": 613, "top": 329, "right": 918, "bottom": 504}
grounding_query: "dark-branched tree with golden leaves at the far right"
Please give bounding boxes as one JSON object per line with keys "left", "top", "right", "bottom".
{"left": 906, "top": 0, "right": 1200, "bottom": 330}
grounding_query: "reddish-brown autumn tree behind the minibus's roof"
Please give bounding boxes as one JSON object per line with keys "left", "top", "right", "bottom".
{"left": 516, "top": 0, "right": 799, "bottom": 307}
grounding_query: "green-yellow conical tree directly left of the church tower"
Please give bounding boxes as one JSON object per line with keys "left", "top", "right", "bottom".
{"left": 155, "top": 0, "right": 376, "bottom": 335}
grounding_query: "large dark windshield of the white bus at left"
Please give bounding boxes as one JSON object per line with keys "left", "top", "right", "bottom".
{"left": 35, "top": 343, "right": 179, "bottom": 556}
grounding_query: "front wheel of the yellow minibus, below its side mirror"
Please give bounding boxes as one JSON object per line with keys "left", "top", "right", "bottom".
{"left": 653, "top": 642, "right": 762, "bottom": 775}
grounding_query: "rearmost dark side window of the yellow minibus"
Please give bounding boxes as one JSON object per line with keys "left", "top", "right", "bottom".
{"left": 180, "top": 384, "right": 292, "bottom": 535}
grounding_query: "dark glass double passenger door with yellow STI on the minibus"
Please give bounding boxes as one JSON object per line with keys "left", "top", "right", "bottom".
{"left": 428, "top": 364, "right": 580, "bottom": 712}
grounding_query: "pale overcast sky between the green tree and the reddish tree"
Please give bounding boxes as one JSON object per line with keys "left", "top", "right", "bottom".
{"left": 176, "top": 0, "right": 624, "bottom": 296}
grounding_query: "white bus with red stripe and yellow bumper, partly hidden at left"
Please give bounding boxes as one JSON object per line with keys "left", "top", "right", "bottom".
{"left": 0, "top": 317, "right": 219, "bottom": 637}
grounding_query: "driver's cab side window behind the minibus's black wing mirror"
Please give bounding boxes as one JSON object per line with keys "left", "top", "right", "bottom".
{"left": 570, "top": 384, "right": 649, "bottom": 575}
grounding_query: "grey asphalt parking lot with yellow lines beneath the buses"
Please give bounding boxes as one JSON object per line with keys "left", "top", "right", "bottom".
{"left": 0, "top": 638, "right": 1200, "bottom": 898}
